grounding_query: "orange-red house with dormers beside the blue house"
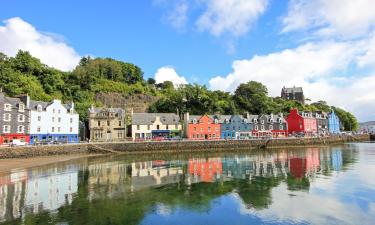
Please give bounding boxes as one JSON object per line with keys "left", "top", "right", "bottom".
{"left": 184, "top": 113, "right": 221, "bottom": 140}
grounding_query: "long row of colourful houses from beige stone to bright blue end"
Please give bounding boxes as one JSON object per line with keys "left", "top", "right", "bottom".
{"left": 89, "top": 107, "right": 340, "bottom": 141}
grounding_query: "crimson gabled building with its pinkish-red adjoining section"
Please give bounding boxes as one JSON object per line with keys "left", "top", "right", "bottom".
{"left": 286, "top": 109, "right": 317, "bottom": 136}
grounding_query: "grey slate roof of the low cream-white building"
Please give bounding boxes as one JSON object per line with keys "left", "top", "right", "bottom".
{"left": 132, "top": 113, "right": 180, "bottom": 125}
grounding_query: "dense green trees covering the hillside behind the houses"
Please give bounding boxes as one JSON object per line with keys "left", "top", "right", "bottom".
{"left": 0, "top": 51, "right": 358, "bottom": 130}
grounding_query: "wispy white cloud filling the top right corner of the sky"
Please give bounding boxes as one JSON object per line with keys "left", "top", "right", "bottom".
{"left": 282, "top": 0, "right": 375, "bottom": 38}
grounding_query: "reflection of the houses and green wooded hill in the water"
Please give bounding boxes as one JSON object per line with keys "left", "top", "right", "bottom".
{"left": 0, "top": 145, "right": 375, "bottom": 224}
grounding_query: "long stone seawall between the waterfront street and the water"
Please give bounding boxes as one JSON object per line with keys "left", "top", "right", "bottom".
{"left": 0, "top": 135, "right": 370, "bottom": 159}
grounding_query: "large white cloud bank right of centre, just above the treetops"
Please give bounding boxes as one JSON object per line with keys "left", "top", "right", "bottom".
{"left": 209, "top": 41, "right": 375, "bottom": 120}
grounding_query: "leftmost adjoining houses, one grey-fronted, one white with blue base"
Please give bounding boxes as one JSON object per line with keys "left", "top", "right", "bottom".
{"left": 0, "top": 92, "right": 79, "bottom": 144}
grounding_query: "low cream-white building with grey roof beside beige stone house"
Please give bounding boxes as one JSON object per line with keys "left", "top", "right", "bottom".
{"left": 131, "top": 113, "right": 182, "bottom": 140}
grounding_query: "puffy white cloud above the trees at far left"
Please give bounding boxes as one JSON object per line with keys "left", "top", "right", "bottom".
{"left": 0, "top": 17, "right": 80, "bottom": 71}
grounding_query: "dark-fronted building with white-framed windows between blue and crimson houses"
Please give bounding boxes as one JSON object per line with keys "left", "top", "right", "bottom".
{"left": 251, "top": 114, "right": 288, "bottom": 138}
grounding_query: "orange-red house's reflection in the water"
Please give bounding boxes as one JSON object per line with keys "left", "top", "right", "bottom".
{"left": 188, "top": 158, "right": 223, "bottom": 182}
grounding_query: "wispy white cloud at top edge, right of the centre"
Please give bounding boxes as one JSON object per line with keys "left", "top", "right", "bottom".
{"left": 196, "top": 0, "right": 268, "bottom": 36}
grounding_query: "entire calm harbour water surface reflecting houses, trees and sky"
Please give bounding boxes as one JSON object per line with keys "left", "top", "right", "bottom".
{"left": 0, "top": 143, "right": 375, "bottom": 225}
